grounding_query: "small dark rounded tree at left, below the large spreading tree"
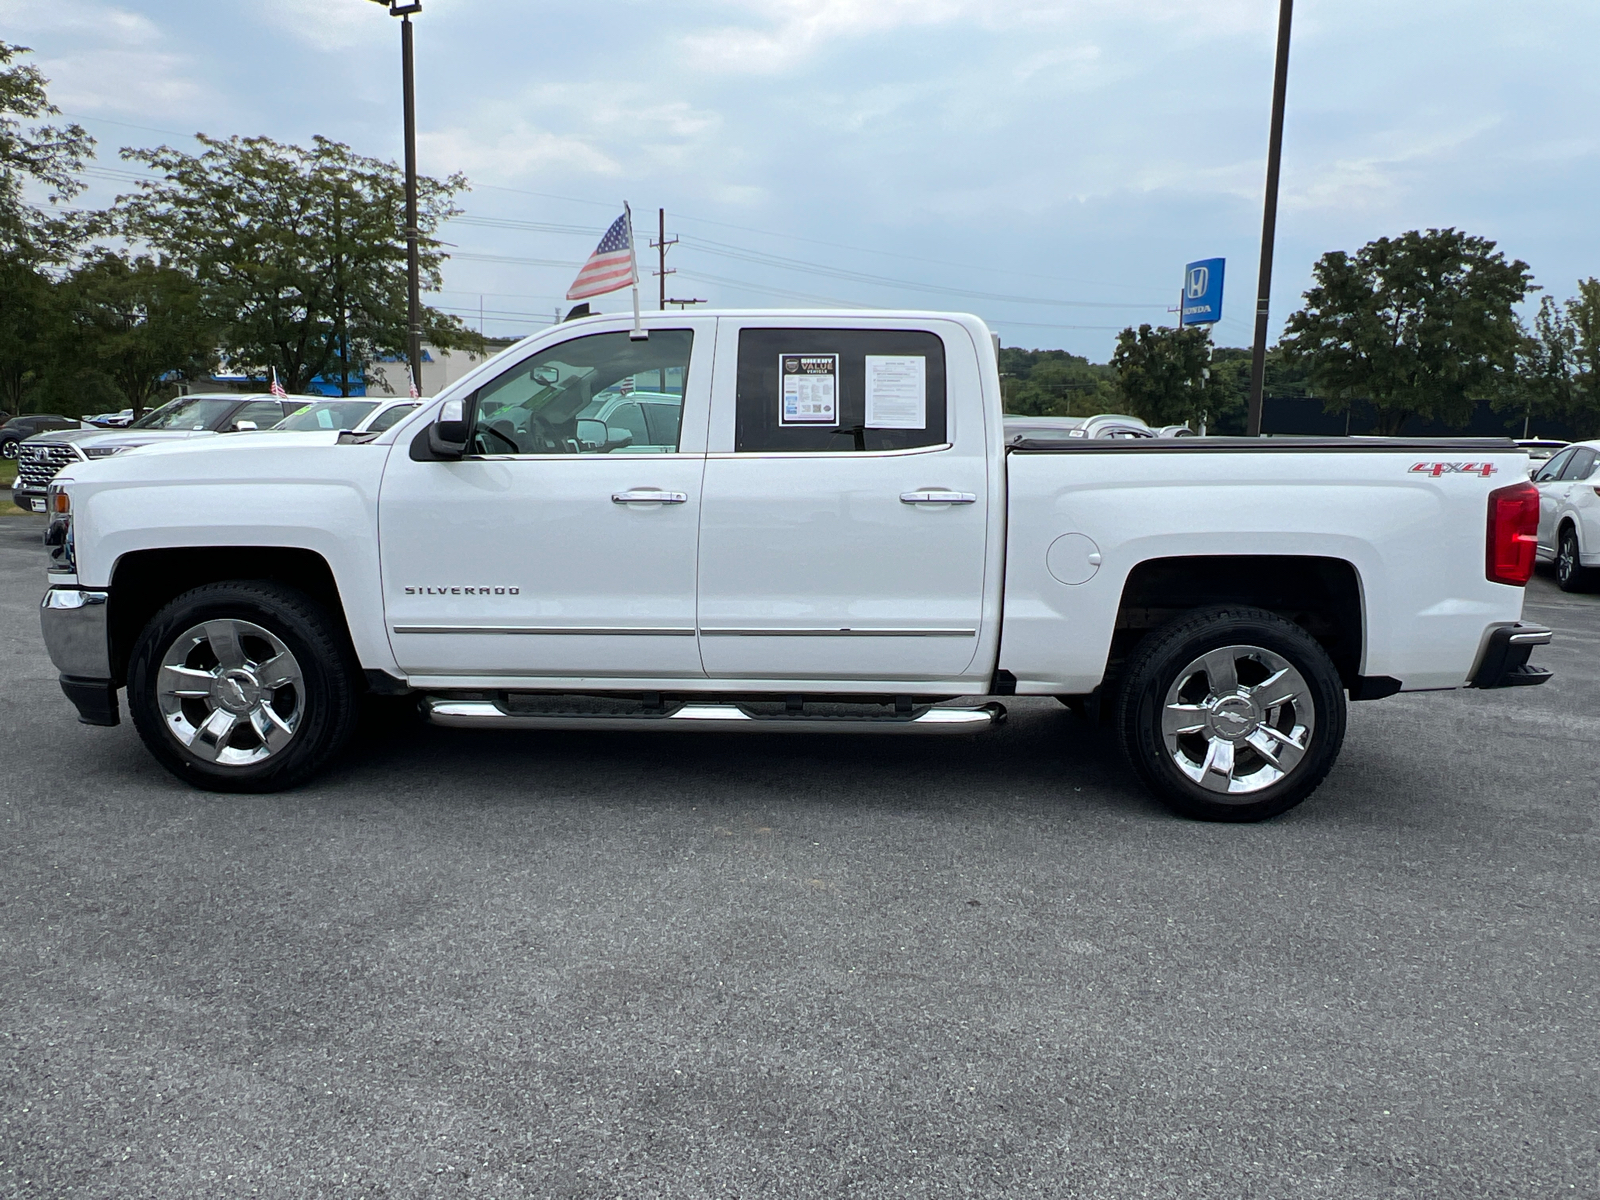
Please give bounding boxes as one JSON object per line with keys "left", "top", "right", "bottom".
{"left": 54, "top": 251, "right": 216, "bottom": 416}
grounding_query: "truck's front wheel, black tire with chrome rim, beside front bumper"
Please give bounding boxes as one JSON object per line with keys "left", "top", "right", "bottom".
{"left": 128, "top": 581, "right": 362, "bottom": 792}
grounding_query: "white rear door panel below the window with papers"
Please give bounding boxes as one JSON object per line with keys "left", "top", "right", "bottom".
{"left": 699, "top": 451, "right": 987, "bottom": 680}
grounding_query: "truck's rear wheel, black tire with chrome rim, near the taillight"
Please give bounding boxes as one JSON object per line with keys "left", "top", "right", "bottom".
{"left": 1114, "top": 605, "right": 1346, "bottom": 821}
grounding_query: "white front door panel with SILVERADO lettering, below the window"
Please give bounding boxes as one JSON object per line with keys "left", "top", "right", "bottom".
{"left": 381, "top": 451, "right": 704, "bottom": 678}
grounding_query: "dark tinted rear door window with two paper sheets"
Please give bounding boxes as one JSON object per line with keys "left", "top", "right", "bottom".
{"left": 733, "top": 330, "right": 949, "bottom": 454}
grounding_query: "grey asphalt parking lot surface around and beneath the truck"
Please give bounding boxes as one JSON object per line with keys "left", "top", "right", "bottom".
{"left": 0, "top": 515, "right": 1600, "bottom": 1200}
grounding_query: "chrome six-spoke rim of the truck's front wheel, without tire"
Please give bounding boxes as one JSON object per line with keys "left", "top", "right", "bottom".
{"left": 155, "top": 619, "right": 306, "bottom": 766}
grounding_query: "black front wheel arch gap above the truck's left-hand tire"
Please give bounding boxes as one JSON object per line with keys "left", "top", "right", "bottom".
{"left": 106, "top": 546, "right": 350, "bottom": 685}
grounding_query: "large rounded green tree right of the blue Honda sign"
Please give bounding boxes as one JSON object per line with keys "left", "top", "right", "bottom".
{"left": 1283, "top": 229, "right": 1533, "bottom": 434}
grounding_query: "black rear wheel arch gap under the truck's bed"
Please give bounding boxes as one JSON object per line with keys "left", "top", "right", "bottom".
{"left": 1106, "top": 554, "right": 1366, "bottom": 693}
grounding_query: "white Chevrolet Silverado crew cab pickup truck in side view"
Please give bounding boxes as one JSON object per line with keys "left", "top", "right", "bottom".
{"left": 42, "top": 312, "right": 1550, "bottom": 821}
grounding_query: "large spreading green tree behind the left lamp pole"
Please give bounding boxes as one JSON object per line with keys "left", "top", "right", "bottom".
{"left": 118, "top": 136, "right": 480, "bottom": 390}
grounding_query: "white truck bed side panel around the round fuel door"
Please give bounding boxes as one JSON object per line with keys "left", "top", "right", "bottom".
{"left": 1000, "top": 448, "right": 1526, "bottom": 694}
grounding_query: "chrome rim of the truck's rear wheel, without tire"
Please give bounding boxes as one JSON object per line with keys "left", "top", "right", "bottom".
{"left": 1162, "top": 646, "right": 1317, "bottom": 797}
